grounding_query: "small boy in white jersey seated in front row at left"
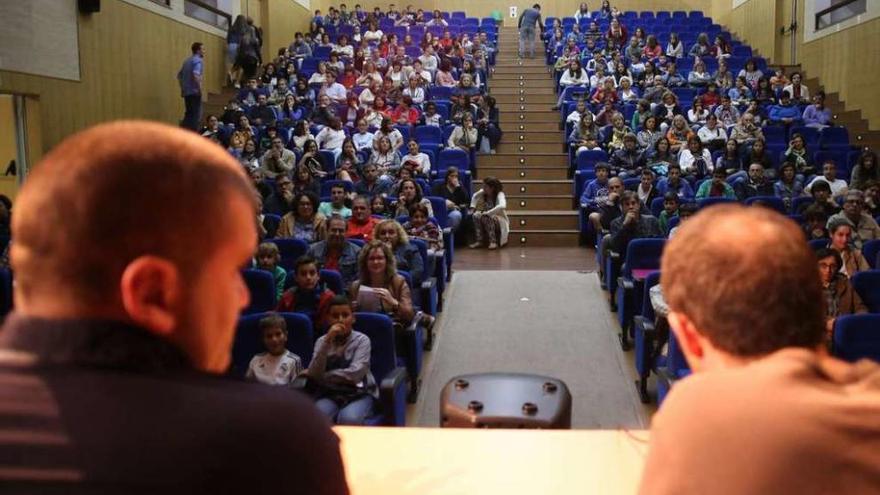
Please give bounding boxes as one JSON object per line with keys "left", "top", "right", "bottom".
{"left": 245, "top": 313, "right": 303, "bottom": 385}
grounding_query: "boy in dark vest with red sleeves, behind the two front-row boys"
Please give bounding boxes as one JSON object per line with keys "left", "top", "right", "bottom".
{"left": 275, "top": 254, "right": 336, "bottom": 329}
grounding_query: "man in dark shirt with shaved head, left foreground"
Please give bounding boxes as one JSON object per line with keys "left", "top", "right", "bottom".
{"left": 0, "top": 122, "right": 348, "bottom": 494}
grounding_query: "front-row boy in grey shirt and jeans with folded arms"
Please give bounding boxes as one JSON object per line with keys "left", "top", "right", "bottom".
{"left": 306, "top": 296, "right": 378, "bottom": 425}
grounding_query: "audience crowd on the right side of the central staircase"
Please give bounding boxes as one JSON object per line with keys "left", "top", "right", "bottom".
{"left": 560, "top": 3, "right": 880, "bottom": 344}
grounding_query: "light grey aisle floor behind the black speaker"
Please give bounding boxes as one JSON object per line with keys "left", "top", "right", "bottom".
{"left": 410, "top": 271, "right": 648, "bottom": 429}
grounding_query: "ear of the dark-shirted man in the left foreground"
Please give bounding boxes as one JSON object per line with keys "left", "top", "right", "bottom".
{"left": 120, "top": 256, "right": 182, "bottom": 335}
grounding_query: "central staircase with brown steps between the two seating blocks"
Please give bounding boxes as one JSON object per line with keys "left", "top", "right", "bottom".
{"left": 478, "top": 27, "right": 578, "bottom": 247}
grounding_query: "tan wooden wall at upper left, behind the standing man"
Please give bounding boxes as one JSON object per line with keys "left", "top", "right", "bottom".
{"left": 0, "top": 2, "right": 225, "bottom": 149}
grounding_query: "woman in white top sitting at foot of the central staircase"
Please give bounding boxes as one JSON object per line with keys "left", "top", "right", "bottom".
{"left": 470, "top": 177, "right": 510, "bottom": 249}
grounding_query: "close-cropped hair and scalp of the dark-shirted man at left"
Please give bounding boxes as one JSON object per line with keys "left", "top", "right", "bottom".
{"left": 11, "top": 122, "right": 253, "bottom": 308}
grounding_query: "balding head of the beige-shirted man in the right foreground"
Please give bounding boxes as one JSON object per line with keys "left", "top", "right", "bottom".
{"left": 661, "top": 205, "right": 824, "bottom": 357}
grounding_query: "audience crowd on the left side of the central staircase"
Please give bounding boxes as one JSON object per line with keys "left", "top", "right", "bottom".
{"left": 200, "top": 4, "right": 509, "bottom": 424}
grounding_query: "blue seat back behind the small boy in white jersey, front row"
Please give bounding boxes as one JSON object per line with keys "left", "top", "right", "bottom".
{"left": 230, "top": 313, "right": 314, "bottom": 376}
